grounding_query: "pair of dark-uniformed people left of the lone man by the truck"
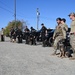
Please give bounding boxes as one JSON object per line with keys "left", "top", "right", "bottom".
{"left": 24, "top": 26, "right": 36, "bottom": 45}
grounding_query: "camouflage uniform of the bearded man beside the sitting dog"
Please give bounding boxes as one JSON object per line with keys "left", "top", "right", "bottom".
{"left": 53, "top": 24, "right": 68, "bottom": 54}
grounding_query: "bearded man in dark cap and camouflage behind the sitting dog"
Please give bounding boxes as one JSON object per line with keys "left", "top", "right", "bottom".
{"left": 53, "top": 18, "right": 67, "bottom": 55}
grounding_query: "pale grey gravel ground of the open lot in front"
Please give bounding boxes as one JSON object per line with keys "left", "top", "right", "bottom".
{"left": 0, "top": 38, "right": 75, "bottom": 75}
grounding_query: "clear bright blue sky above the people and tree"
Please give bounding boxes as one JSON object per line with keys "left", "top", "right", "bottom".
{"left": 0, "top": 0, "right": 75, "bottom": 29}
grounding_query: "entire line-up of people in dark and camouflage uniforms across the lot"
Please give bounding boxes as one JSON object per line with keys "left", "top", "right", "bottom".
{"left": 1, "top": 12, "right": 75, "bottom": 59}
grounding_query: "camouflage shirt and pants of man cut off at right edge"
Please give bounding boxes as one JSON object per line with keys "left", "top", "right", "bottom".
{"left": 70, "top": 20, "right": 75, "bottom": 58}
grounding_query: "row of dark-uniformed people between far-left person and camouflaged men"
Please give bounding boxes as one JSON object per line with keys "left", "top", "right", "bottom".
{"left": 10, "top": 23, "right": 47, "bottom": 45}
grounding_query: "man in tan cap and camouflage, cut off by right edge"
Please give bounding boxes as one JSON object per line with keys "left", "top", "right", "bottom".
{"left": 68, "top": 12, "right": 75, "bottom": 59}
